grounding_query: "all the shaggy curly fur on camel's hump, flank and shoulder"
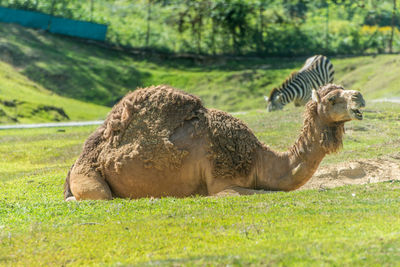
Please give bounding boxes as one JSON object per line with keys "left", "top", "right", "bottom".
{"left": 94, "top": 86, "right": 259, "bottom": 180}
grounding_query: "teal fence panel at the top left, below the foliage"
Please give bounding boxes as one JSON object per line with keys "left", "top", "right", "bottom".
{"left": 0, "top": 7, "right": 107, "bottom": 41}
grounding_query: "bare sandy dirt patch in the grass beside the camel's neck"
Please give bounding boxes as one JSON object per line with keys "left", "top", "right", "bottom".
{"left": 300, "top": 154, "right": 400, "bottom": 190}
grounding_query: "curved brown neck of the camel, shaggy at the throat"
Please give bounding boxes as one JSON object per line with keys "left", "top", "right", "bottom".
{"left": 256, "top": 108, "right": 343, "bottom": 191}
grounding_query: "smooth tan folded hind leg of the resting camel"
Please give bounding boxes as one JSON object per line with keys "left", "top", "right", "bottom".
{"left": 66, "top": 167, "right": 112, "bottom": 200}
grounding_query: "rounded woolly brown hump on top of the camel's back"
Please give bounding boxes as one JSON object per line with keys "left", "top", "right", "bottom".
{"left": 105, "top": 85, "right": 203, "bottom": 142}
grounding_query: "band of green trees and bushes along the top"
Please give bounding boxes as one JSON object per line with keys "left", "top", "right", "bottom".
{"left": 0, "top": 0, "right": 400, "bottom": 56}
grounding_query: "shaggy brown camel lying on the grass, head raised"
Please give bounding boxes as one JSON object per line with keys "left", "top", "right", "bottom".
{"left": 64, "top": 84, "right": 365, "bottom": 201}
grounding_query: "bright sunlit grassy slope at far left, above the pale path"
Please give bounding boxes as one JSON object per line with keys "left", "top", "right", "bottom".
{"left": 0, "top": 59, "right": 108, "bottom": 123}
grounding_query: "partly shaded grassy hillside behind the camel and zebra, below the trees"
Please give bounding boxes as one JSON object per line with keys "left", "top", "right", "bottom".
{"left": 0, "top": 24, "right": 400, "bottom": 121}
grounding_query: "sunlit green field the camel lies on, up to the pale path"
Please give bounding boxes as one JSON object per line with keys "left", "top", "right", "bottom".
{"left": 0, "top": 103, "right": 400, "bottom": 266}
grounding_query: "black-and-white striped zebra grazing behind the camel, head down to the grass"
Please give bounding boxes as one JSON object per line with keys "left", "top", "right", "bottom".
{"left": 264, "top": 55, "right": 335, "bottom": 112}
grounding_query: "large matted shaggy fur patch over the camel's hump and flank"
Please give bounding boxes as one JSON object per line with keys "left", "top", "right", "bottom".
{"left": 101, "top": 86, "right": 203, "bottom": 172}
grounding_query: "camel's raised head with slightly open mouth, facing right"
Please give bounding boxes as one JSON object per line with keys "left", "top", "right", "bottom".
{"left": 312, "top": 84, "right": 365, "bottom": 124}
